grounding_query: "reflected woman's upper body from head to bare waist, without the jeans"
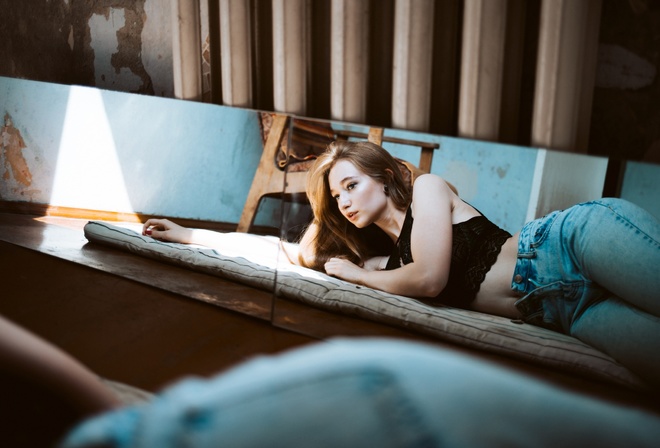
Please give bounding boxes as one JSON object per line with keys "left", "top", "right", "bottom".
{"left": 300, "top": 142, "right": 519, "bottom": 317}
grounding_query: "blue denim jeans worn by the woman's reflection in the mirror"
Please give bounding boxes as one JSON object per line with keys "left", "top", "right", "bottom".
{"left": 512, "top": 199, "right": 660, "bottom": 387}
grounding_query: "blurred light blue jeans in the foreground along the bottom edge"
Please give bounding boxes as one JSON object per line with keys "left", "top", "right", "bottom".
{"left": 62, "top": 339, "right": 660, "bottom": 448}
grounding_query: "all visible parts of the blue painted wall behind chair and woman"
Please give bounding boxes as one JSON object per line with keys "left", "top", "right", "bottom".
{"left": 5, "top": 77, "right": 660, "bottom": 232}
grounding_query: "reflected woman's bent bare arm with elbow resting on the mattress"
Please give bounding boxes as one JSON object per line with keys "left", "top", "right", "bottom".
{"left": 326, "top": 175, "right": 453, "bottom": 297}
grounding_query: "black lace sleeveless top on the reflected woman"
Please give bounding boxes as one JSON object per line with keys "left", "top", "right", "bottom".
{"left": 385, "top": 208, "right": 511, "bottom": 308}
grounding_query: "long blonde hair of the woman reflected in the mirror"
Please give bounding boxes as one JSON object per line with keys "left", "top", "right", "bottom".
{"left": 301, "top": 140, "right": 412, "bottom": 271}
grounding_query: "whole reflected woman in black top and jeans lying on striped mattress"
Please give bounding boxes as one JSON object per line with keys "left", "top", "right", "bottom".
{"left": 143, "top": 141, "right": 660, "bottom": 389}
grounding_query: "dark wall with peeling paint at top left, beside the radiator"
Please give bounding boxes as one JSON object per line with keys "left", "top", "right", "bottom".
{"left": 0, "top": 0, "right": 180, "bottom": 98}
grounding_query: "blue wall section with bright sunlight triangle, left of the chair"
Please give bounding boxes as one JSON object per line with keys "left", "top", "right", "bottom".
{"left": 0, "top": 77, "right": 263, "bottom": 222}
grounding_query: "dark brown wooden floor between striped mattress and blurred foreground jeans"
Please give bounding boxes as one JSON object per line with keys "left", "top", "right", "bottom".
{"left": 0, "top": 213, "right": 660, "bottom": 412}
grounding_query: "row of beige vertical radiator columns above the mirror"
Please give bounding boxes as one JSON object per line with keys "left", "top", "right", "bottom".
{"left": 180, "top": 0, "right": 602, "bottom": 151}
